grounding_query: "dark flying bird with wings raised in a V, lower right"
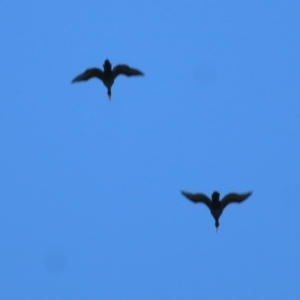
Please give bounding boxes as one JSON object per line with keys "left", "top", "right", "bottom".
{"left": 181, "top": 191, "right": 252, "bottom": 230}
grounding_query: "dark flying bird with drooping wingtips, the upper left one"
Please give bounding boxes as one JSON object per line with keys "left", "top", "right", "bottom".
{"left": 72, "top": 59, "right": 144, "bottom": 99}
